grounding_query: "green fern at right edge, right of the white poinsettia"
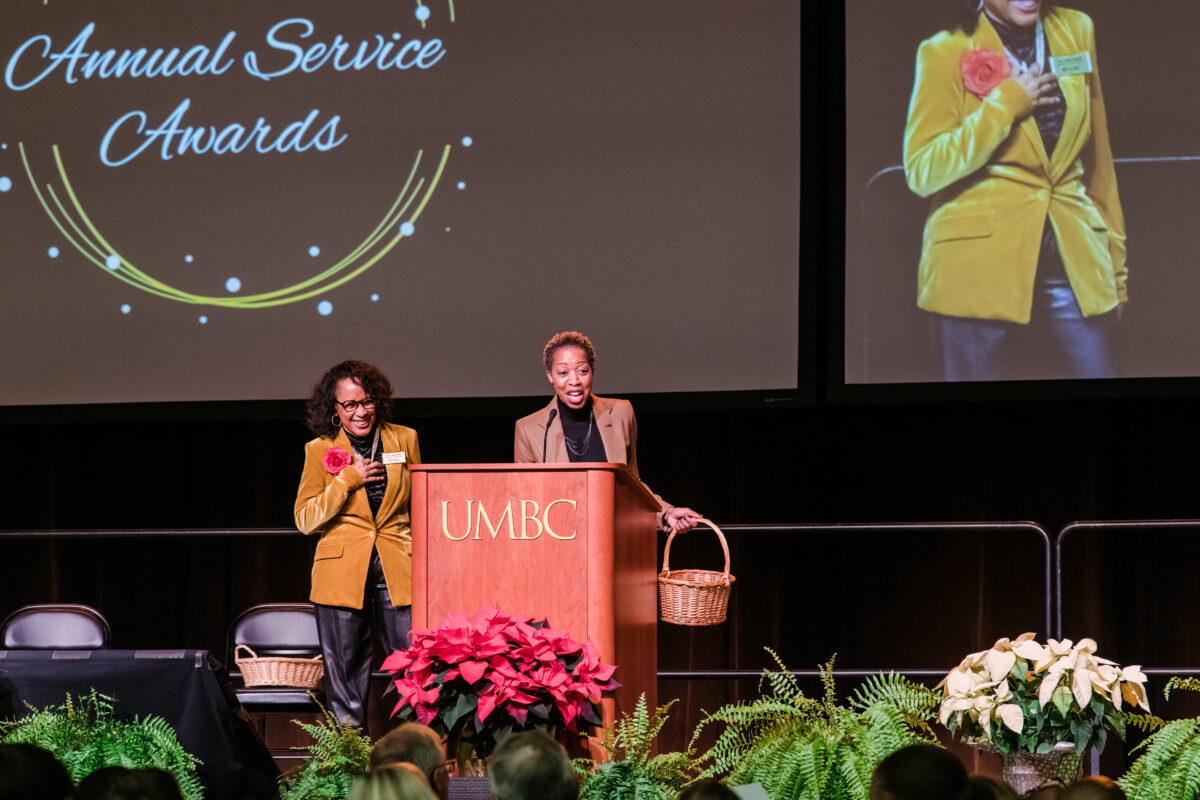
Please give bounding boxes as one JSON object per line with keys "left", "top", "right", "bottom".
{"left": 1120, "top": 678, "right": 1200, "bottom": 800}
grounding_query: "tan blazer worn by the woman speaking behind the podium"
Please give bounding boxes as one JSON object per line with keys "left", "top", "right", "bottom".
{"left": 512, "top": 395, "right": 674, "bottom": 527}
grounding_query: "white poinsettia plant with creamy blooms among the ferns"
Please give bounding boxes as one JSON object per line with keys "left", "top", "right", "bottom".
{"left": 937, "top": 633, "right": 1150, "bottom": 753}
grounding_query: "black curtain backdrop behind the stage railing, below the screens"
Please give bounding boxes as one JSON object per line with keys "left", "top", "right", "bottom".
{"left": 0, "top": 397, "right": 1200, "bottom": 746}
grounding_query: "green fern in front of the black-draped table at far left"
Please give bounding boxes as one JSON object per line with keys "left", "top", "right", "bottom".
{"left": 0, "top": 690, "right": 204, "bottom": 800}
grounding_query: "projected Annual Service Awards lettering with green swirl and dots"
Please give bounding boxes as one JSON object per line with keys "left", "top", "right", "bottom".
{"left": 8, "top": 0, "right": 458, "bottom": 323}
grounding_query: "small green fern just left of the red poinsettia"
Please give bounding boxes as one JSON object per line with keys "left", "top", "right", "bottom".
{"left": 280, "top": 703, "right": 371, "bottom": 800}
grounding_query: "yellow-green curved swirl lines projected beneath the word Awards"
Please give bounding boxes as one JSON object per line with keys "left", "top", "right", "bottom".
{"left": 18, "top": 143, "right": 450, "bottom": 308}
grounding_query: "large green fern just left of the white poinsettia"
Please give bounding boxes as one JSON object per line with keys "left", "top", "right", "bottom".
{"left": 689, "top": 648, "right": 941, "bottom": 800}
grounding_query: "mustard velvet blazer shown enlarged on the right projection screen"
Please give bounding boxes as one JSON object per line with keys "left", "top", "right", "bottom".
{"left": 904, "top": 8, "right": 1128, "bottom": 323}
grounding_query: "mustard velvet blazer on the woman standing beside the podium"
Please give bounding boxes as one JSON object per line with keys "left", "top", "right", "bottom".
{"left": 295, "top": 422, "right": 421, "bottom": 608}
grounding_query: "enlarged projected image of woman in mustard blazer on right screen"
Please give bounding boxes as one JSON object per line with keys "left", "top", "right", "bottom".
{"left": 904, "top": 0, "right": 1128, "bottom": 380}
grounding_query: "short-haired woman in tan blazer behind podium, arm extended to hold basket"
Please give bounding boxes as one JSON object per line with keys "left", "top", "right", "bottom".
{"left": 512, "top": 331, "right": 700, "bottom": 533}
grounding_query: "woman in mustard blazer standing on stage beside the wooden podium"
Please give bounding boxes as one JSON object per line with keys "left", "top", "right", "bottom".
{"left": 295, "top": 361, "right": 421, "bottom": 728}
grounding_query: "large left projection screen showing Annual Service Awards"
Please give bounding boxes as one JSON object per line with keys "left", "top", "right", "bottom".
{"left": 0, "top": 0, "right": 799, "bottom": 405}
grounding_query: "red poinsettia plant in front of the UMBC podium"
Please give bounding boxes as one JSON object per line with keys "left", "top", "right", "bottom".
{"left": 383, "top": 604, "right": 619, "bottom": 758}
